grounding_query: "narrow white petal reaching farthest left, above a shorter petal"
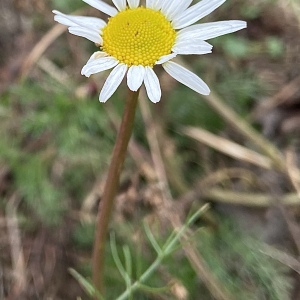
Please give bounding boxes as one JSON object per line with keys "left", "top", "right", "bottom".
{"left": 52, "top": 10, "right": 106, "bottom": 30}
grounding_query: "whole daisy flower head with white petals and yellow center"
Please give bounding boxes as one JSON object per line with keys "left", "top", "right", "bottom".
{"left": 53, "top": 0, "right": 247, "bottom": 103}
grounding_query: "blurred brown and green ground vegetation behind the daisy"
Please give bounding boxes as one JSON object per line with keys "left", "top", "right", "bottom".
{"left": 0, "top": 0, "right": 300, "bottom": 300}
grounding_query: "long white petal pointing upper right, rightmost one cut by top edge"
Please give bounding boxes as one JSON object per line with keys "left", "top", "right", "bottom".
{"left": 172, "top": 0, "right": 226, "bottom": 29}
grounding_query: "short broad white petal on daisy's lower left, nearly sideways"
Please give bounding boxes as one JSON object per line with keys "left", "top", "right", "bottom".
{"left": 81, "top": 54, "right": 119, "bottom": 77}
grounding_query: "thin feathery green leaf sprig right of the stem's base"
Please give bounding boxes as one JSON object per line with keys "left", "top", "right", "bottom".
{"left": 93, "top": 205, "right": 209, "bottom": 300}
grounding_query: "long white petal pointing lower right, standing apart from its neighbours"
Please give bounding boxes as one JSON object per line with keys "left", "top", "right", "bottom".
{"left": 162, "top": 61, "right": 210, "bottom": 95}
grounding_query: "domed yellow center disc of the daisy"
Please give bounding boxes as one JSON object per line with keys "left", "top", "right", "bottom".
{"left": 102, "top": 7, "right": 176, "bottom": 67}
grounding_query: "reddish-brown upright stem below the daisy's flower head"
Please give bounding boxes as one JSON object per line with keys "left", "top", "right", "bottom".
{"left": 92, "top": 91, "right": 139, "bottom": 300}
